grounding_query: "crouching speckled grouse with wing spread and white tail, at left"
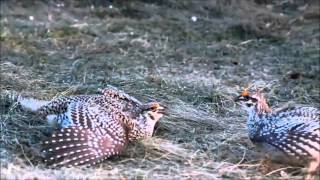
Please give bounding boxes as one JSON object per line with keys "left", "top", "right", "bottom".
{"left": 18, "top": 86, "right": 164, "bottom": 167}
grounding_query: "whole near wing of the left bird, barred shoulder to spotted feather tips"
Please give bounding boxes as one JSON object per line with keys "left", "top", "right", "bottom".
{"left": 44, "top": 98, "right": 127, "bottom": 166}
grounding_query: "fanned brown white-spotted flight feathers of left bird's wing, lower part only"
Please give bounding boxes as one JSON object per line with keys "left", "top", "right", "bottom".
{"left": 43, "top": 126, "right": 126, "bottom": 167}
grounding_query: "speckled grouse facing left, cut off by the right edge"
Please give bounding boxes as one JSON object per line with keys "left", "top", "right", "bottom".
{"left": 235, "top": 90, "right": 320, "bottom": 179}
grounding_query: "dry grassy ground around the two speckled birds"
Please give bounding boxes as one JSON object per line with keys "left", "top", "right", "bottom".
{"left": 0, "top": 0, "right": 320, "bottom": 179}
